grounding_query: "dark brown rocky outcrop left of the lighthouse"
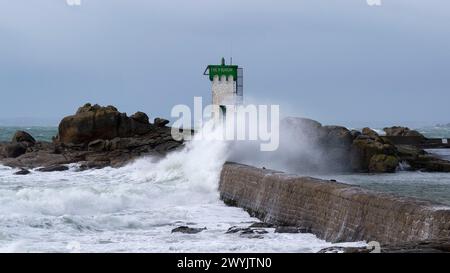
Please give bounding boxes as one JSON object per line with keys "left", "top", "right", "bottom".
{"left": 0, "top": 104, "right": 182, "bottom": 171}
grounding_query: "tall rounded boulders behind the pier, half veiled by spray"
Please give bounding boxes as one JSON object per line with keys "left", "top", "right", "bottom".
{"left": 280, "top": 117, "right": 399, "bottom": 173}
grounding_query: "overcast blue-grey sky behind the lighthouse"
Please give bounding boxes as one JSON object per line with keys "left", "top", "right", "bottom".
{"left": 0, "top": 0, "right": 450, "bottom": 126}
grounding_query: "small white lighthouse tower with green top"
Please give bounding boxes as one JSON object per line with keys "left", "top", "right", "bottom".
{"left": 204, "top": 58, "right": 244, "bottom": 109}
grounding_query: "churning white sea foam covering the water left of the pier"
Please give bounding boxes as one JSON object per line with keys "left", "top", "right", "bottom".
{"left": 0, "top": 122, "right": 362, "bottom": 252}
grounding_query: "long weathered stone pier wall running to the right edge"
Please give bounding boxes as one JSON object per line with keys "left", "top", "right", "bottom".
{"left": 219, "top": 163, "right": 450, "bottom": 244}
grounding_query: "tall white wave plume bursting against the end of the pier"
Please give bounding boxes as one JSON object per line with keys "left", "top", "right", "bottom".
{"left": 123, "top": 120, "right": 228, "bottom": 196}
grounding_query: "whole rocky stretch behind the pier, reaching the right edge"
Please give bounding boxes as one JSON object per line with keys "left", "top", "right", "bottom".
{"left": 280, "top": 117, "right": 450, "bottom": 173}
